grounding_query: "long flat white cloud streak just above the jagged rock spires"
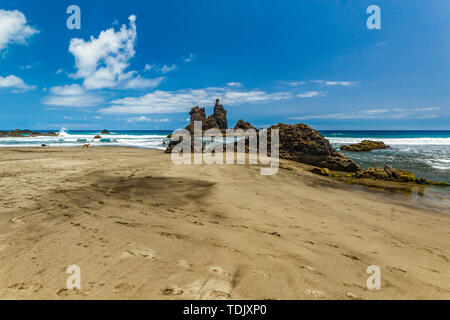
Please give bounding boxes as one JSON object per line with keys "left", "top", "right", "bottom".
{"left": 100, "top": 87, "right": 292, "bottom": 114}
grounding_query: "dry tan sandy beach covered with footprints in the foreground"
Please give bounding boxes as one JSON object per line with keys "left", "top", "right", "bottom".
{"left": 0, "top": 148, "right": 450, "bottom": 299}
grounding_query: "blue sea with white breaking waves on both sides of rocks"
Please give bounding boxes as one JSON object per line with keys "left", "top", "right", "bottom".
{"left": 0, "top": 129, "right": 450, "bottom": 182}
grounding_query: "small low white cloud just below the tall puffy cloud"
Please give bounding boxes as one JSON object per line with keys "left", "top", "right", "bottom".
{"left": 42, "top": 84, "right": 104, "bottom": 107}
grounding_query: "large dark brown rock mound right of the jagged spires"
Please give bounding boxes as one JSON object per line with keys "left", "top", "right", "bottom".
{"left": 267, "top": 123, "right": 361, "bottom": 172}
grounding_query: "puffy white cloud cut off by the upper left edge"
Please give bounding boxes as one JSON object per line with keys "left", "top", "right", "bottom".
{"left": 0, "top": 9, "right": 39, "bottom": 51}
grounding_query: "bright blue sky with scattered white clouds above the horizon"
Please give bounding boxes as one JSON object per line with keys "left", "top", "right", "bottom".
{"left": 0, "top": 0, "right": 450, "bottom": 130}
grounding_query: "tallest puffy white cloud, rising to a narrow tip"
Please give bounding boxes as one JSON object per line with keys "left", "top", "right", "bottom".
{"left": 69, "top": 15, "right": 160, "bottom": 89}
